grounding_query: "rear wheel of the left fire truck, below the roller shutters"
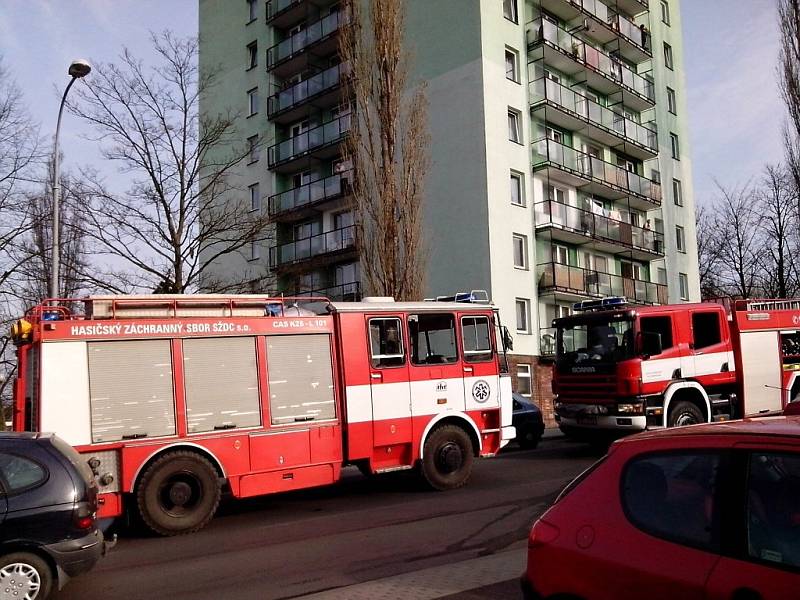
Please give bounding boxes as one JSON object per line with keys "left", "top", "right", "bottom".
{"left": 136, "top": 450, "right": 221, "bottom": 536}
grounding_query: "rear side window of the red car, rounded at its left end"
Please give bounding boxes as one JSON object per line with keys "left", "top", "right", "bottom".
{"left": 622, "top": 452, "right": 720, "bottom": 551}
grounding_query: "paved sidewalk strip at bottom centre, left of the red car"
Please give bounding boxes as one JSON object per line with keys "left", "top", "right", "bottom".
{"left": 290, "top": 547, "right": 527, "bottom": 600}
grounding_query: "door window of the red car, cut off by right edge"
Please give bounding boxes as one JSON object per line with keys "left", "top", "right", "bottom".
{"left": 747, "top": 453, "right": 800, "bottom": 567}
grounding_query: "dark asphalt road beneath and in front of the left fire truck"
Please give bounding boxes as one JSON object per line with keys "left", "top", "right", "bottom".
{"left": 56, "top": 438, "right": 597, "bottom": 600}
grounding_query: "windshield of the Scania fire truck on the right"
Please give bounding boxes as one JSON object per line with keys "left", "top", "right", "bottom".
{"left": 556, "top": 317, "right": 634, "bottom": 367}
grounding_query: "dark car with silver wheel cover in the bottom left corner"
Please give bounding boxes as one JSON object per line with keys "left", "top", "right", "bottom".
{"left": 0, "top": 433, "right": 105, "bottom": 600}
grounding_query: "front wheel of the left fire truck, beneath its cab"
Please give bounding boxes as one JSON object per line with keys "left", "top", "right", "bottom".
{"left": 422, "top": 425, "right": 475, "bottom": 491}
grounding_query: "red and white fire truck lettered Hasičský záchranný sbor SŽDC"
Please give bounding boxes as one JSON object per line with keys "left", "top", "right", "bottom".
{"left": 12, "top": 294, "right": 514, "bottom": 535}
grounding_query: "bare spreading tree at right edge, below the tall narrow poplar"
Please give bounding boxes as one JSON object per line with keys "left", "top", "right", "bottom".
{"left": 758, "top": 165, "right": 798, "bottom": 298}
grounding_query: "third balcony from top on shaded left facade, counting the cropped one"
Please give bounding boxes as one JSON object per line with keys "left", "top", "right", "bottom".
{"left": 267, "top": 63, "right": 350, "bottom": 123}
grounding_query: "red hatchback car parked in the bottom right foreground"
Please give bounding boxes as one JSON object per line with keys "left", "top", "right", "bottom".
{"left": 522, "top": 416, "right": 800, "bottom": 600}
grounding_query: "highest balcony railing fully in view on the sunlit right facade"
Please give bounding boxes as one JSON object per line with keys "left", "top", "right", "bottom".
{"left": 528, "top": 19, "right": 656, "bottom": 103}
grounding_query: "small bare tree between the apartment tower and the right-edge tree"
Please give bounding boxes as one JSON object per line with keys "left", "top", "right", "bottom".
{"left": 713, "top": 183, "right": 763, "bottom": 298}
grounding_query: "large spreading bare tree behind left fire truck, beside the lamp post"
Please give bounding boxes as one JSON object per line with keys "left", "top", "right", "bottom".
{"left": 69, "top": 32, "right": 267, "bottom": 293}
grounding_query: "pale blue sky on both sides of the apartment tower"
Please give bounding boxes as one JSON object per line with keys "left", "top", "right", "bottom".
{"left": 0, "top": 0, "right": 785, "bottom": 209}
